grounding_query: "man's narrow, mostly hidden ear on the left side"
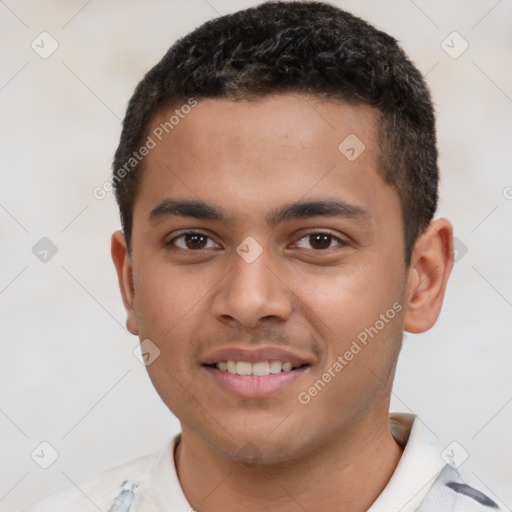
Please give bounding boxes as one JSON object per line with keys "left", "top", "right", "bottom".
{"left": 111, "top": 231, "right": 139, "bottom": 335}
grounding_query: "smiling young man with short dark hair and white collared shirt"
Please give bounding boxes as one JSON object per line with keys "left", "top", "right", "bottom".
{"left": 26, "top": 2, "right": 498, "bottom": 512}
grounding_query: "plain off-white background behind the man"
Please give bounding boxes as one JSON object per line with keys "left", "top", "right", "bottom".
{"left": 0, "top": 0, "right": 512, "bottom": 511}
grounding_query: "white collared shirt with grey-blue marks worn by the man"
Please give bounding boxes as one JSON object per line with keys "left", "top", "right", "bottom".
{"left": 25, "top": 413, "right": 500, "bottom": 512}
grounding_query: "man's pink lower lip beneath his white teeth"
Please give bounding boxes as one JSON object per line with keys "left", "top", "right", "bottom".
{"left": 203, "top": 366, "right": 309, "bottom": 398}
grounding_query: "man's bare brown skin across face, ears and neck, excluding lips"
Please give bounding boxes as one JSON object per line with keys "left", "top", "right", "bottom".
{"left": 112, "top": 94, "right": 452, "bottom": 512}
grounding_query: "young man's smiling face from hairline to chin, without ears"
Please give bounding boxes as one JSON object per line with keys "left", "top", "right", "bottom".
{"left": 114, "top": 94, "right": 424, "bottom": 463}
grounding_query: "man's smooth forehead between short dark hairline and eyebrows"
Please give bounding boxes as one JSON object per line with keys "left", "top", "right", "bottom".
{"left": 135, "top": 94, "right": 397, "bottom": 231}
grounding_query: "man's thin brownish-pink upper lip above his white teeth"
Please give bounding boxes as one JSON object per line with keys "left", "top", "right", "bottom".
{"left": 202, "top": 346, "right": 311, "bottom": 366}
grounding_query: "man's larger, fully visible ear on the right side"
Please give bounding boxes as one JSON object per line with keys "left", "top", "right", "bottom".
{"left": 404, "top": 219, "right": 453, "bottom": 333}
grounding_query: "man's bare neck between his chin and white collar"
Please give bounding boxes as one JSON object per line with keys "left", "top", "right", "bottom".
{"left": 175, "top": 416, "right": 402, "bottom": 512}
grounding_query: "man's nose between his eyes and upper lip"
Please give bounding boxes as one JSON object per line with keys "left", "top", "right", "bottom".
{"left": 212, "top": 246, "right": 293, "bottom": 329}
